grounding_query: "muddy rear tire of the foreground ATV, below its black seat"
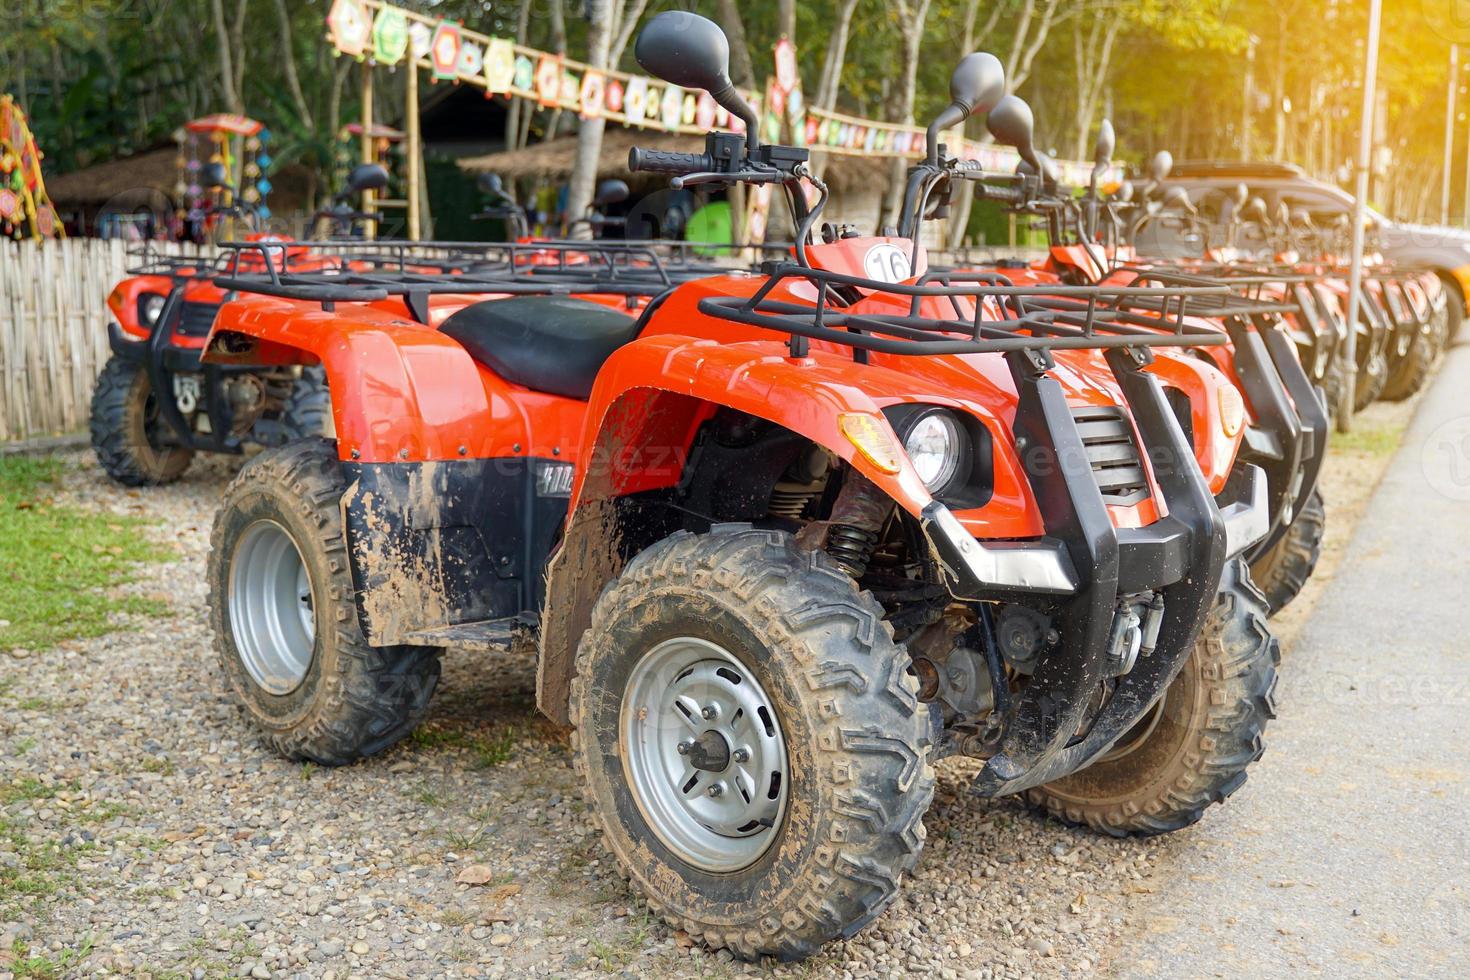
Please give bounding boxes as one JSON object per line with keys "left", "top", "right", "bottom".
{"left": 207, "top": 439, "right": 440, "bottom": 765}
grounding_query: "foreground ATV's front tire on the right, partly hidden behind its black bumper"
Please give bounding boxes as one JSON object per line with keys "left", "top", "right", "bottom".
{"left": 1026, "top": 558, "right": 1280, "bottom": 837}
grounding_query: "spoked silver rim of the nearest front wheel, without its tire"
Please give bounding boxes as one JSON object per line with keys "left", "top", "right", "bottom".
{"left": 619, "top": 636, "right": 791, "bottom": 873}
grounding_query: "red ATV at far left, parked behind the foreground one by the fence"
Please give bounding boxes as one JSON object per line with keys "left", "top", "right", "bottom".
{"left": 90, "top": 163, "right": 387, "bottom": 486}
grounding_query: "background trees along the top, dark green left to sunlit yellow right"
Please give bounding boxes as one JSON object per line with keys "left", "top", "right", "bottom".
{"left": 0, "top": 0, "right": 1470, "bottom": 217}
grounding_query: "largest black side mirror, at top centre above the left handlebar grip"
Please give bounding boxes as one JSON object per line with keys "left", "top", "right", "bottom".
{"left": 634, "top": 10, "right": 760, "bottom": 153}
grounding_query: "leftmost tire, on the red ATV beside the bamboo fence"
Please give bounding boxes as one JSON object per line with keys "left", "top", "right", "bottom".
{"left": 90, "top": 357, "right": 194, "bottom": 486}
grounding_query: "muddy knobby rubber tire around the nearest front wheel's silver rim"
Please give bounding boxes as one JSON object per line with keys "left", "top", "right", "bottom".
{"left": 570, "top": 525, "right": 935, "bottom": 959}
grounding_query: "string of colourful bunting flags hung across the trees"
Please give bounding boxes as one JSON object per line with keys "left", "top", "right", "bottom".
{"left": 326, "top": 0, "right": 1117, "bottom": 184}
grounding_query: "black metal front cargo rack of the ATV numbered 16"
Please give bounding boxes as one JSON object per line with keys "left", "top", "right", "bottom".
{"left": 700, "top": 263, "right": 1229, "bottom": 360}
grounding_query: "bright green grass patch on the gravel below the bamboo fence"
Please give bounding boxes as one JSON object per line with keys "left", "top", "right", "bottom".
{"left": 0, "top": 455, "right": 171, "bottom": 649}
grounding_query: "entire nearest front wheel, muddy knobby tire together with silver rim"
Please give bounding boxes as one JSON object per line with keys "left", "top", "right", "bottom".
{"left": 570, "top": 525, "right": 935, "bottom": 959}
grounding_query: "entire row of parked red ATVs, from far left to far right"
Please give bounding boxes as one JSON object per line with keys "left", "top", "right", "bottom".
{"left": 93, "top": 12, "right": 1458, "bottom": 958}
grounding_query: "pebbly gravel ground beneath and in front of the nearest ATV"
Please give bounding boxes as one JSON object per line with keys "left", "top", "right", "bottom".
{"left": 0, "top": 390, "right": 1422, "bottom": 980}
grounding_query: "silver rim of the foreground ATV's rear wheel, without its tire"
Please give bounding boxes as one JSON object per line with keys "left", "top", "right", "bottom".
{"left": 229, "top": 520, "right": 316, "bottom": 695}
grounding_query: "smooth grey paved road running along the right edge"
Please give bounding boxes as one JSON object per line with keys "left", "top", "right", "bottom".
{"left": 1111, "top": 344, "right": 1470, "bottom": 977}
